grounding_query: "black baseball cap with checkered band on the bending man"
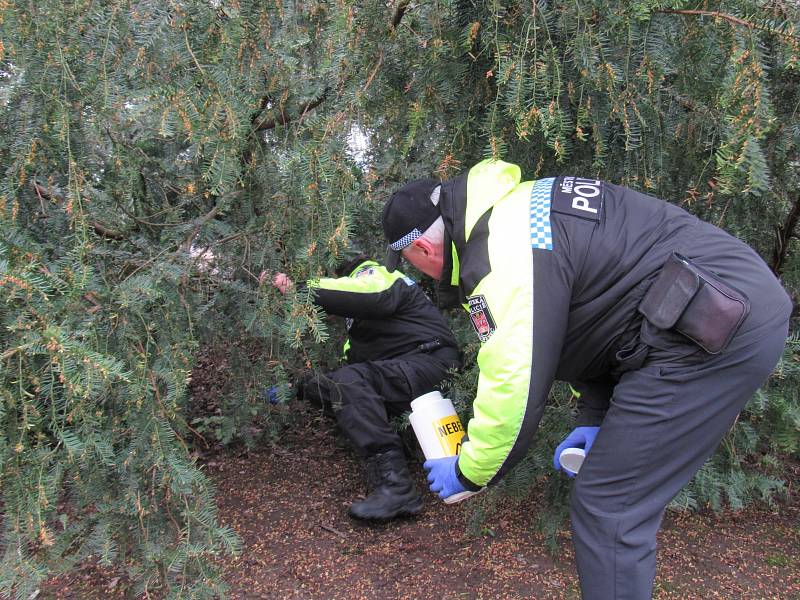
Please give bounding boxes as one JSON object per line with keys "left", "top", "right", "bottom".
{"left": 381, "top": 179, "right": 441, "bottom": 271}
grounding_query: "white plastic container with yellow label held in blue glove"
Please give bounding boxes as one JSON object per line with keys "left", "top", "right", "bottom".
{"left": 409, "top": 391, "right": 477, "bottom": 504}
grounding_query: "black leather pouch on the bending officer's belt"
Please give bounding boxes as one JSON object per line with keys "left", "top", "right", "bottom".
{"left": 639, "top": 253, "right": 750, "bottom": 354}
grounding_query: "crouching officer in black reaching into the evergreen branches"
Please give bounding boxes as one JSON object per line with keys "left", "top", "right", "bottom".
{"left": 273, "top": 254, "right": 459, "bottom": 520}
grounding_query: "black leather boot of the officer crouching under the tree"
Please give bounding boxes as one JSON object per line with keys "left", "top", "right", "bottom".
{"left": 350, "top": 450, "right": 422, "bottom": 521}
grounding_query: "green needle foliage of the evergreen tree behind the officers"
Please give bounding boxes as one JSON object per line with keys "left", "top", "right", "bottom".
{"left": 0, "top": 0, "right": 800, "bottom": 598}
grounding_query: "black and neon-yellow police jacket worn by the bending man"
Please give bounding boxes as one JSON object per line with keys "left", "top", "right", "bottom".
{"left": 440, "top": 161, "right": 697, "bottom": 487}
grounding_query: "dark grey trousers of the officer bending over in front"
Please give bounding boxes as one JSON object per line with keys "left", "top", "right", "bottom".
{"left": 570, "top": 238, "right": 791, "bottom": 600}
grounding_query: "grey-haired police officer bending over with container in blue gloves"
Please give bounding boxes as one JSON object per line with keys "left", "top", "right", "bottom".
{"left": 383, "top": 161, "right": 791, "bottom": 600}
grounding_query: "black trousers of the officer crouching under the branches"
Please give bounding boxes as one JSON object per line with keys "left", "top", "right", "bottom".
{"left": 303, "top": 347, "right": 458, "bottom": 457}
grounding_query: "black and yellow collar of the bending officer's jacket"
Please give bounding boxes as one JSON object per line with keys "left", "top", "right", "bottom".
{"left": 437, "top": 159, "right": 522, "bottom": 308}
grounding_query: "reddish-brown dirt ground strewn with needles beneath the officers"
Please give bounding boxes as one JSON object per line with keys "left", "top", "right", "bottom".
{"left": 39, "top": 404, "right": 800, "bottom": 600}
